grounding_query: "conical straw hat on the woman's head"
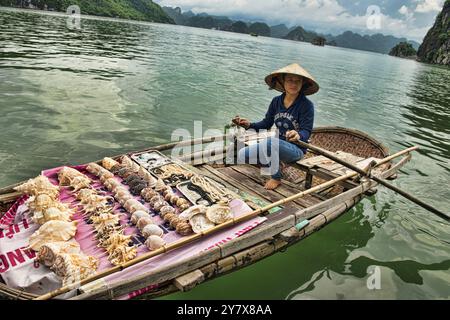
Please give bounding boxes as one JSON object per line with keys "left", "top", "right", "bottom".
{"left": 265, "top": 63, "right": 319, "bottom": 95}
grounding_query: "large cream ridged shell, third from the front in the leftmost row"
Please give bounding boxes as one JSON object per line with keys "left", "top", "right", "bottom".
{"left": 29, "top": 220, "right": 77, "bottom": 251}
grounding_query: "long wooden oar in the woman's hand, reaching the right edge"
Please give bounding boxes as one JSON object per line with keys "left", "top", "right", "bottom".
{"left": 294, "top": 140, "right": 450, "bottom": 221}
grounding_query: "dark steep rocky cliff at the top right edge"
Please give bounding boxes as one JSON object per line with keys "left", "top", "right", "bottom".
{"left": 417, "top": 0, "right": 450, "bottom": 65}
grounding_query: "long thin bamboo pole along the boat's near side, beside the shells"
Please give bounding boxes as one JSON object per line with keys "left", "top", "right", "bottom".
{"left": 35, "top": 148, "right": 411, "bottom": 300}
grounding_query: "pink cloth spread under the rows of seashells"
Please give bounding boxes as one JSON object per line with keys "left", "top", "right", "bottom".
{"left": 0, "top": 165, "right": 266, "bottom": 299}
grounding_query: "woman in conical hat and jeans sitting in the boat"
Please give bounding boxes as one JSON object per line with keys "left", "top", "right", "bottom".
{"left": 232, "top": 63, "right": 319, "bottom": 190}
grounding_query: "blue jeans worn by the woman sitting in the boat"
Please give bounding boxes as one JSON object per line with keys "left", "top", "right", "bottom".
{"left": 237, "top": 137, "right": 303, "bottom": 180}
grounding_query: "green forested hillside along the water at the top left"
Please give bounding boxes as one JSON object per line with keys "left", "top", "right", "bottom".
{"left": 0, "top": 0, "right": 175, "bottom": 24}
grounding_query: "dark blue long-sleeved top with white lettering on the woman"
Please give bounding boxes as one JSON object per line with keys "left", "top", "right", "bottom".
{"left": 250, "top": 93, "right": 314, "bottom": 153}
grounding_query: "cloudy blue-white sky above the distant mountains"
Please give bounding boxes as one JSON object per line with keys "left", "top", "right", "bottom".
{"left": 154, "top": 0, "right": 445, "bottom": 42}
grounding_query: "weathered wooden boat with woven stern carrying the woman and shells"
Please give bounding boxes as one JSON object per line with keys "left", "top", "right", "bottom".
{"left": 0, "top": 127, "right": 411, "bottom": 299}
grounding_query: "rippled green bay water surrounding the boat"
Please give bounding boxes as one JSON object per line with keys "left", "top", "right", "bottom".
{"left": 0, "top": 10, "right": 450, "bottom": 299}
